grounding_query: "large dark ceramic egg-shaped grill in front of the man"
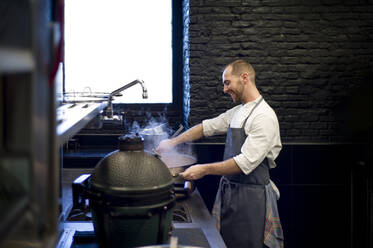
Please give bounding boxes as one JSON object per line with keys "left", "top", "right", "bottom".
{"left": 73, "top": 135, "right": 175, "bottom": 247}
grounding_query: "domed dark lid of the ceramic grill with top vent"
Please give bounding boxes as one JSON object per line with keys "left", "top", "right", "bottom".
{"left": 90, "top": 134, "right": 173, "bottom": 197}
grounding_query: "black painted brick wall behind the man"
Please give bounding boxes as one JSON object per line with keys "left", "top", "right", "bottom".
{"left": 184, "top": 0, "right": 373, "bottom": 142}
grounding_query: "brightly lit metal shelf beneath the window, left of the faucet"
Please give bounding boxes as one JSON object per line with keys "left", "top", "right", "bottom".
{"left": 57, "top": 102, "right": 107, "bottom": 146}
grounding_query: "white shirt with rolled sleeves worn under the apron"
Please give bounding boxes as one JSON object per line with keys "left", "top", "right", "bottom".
{"left": 202, "top": 97, "right": 282, "bottom": 175}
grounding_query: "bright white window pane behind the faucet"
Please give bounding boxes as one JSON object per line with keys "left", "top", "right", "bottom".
{"left": 65, "top": 0, "right": 172, "bottom": 103}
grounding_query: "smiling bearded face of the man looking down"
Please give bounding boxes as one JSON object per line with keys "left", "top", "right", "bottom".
{"left": 222, "top": 66, "right": 244, "bottom": 103}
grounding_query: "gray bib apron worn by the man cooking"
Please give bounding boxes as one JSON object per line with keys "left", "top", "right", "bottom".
{"left": 213, "top": 98, "right": 283, "bottom": 248}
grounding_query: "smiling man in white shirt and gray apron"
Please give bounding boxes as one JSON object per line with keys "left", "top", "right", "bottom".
{"left": 156, "top": 60, "right": 283, "bottom": 248}
